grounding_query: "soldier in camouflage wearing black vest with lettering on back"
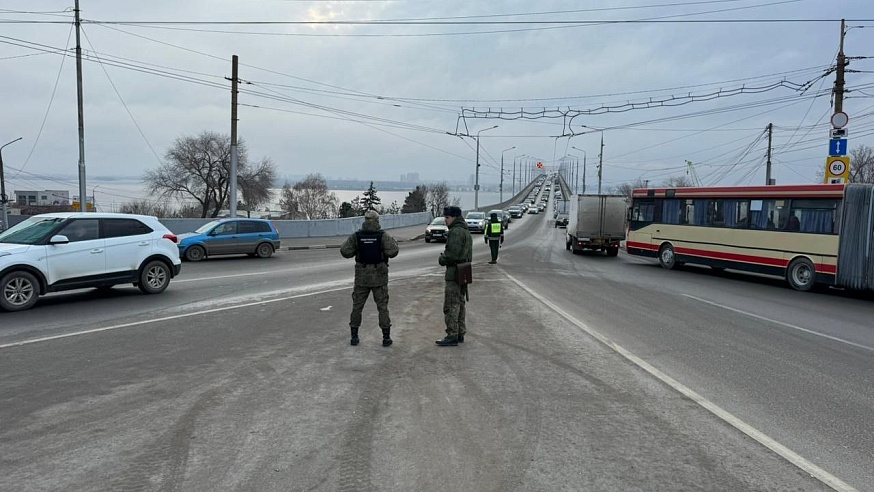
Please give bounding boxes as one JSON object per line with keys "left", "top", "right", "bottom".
{"left": 340, "top": 210, "right": 398, "bottom": 347}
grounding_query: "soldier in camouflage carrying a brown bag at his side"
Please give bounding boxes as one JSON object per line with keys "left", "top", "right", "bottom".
{"left": 436, "top": 207, "right": 473, "bottom": 347}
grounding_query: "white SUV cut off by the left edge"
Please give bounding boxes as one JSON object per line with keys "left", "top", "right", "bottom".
{"left": 0, "top": 212, "right": 182, "bottom": 311}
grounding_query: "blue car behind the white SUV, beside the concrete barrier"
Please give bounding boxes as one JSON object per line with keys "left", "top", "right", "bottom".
{"left": 179, "top": 218, "right": 280, "bottom": 261}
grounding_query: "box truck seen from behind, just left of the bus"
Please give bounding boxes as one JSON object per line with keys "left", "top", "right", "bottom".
{"left": 565, "top": 195, "right": 628, "bottom": 256}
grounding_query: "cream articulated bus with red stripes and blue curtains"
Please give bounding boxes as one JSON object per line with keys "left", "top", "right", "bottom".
{"left": 626, "top": 184, "right": 874, "bottom": 291}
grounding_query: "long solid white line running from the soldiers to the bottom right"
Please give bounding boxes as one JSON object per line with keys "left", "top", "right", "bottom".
{"left": 504, "top": 272, "right": 858, "bottom": 492}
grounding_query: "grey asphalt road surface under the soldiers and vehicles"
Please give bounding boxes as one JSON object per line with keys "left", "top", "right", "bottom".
{"left": 0, "top": 199, "right": 874, "bottom": 491}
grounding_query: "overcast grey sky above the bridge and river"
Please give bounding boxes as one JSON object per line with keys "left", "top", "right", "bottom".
{"left": 0, "top": 0, "right": 874, "bottom": 200}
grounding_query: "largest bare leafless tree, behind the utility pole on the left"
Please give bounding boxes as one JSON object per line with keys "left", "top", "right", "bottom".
{"left": 144, "top": 131, "right": 276, "bottom": 217}
